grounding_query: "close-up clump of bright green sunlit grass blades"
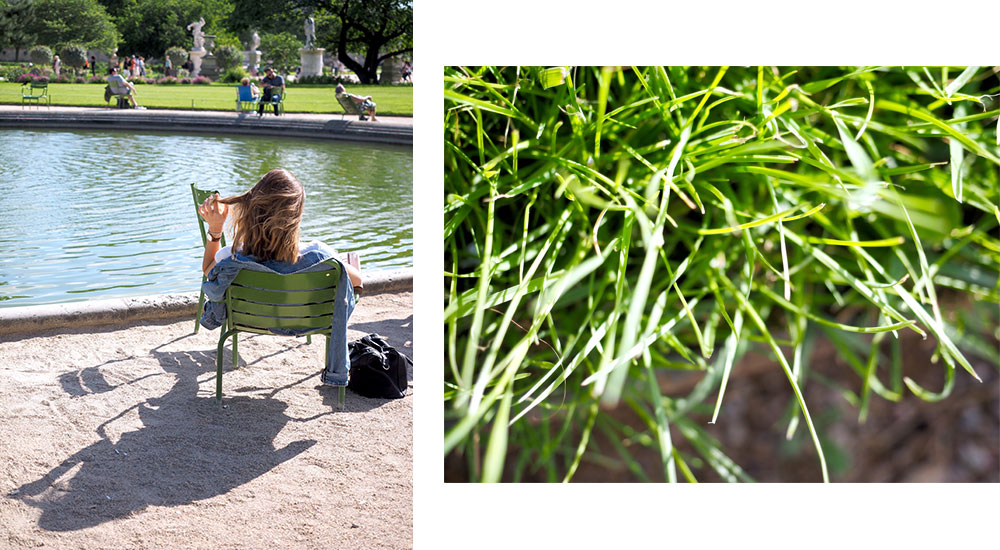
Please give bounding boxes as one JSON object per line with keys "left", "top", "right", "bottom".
{"left": 444, "top": 67, "right": 1000, "bottom": 481}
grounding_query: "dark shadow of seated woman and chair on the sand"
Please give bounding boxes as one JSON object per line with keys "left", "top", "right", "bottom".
{"left": 16, "top": 338, "right": 356, "bottom": 531}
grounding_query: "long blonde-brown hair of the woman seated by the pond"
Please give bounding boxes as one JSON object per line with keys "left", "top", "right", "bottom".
{"left": 219, "top": 168, "right": 306, "bottom": 264}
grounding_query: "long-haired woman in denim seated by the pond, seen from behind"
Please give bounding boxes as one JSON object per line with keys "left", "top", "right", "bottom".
{"left": 198, "top": 168, "right": 363, "bottom": 384}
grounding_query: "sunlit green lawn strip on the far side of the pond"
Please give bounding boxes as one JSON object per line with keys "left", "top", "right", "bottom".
{"left": 0, "top": 82, "right": 413, "bottom": 116}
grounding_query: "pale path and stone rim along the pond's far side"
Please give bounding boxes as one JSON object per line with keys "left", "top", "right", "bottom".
{"left": 0, "top": 105, "right": 413, "bottom": 145}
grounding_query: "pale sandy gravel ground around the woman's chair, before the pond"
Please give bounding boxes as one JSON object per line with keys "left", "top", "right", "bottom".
{"left": 0, "top": 293, "right": 413, "bottom": 549}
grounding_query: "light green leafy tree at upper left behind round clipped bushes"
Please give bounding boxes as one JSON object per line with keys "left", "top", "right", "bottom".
{"left": 26, "top": 0, "right": 118, "bottom": 51}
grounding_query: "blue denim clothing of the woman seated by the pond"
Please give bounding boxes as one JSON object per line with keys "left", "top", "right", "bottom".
{"left": 201, "top": 242, "right": 354, "bottom": 386}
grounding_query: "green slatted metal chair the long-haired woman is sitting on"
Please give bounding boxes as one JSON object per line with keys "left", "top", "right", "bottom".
{"left": 215, "top": 260, "right": 347, "bottom": 408}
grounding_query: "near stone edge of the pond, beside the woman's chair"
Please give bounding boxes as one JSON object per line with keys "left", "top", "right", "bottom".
{"left": 0, "top": 269, "right": 413, "bottom": 336}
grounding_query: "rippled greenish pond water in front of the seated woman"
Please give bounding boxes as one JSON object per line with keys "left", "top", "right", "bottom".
{"left": 0, "top": 130, "right": 413, "bottom": 307}
